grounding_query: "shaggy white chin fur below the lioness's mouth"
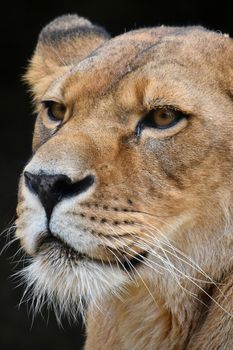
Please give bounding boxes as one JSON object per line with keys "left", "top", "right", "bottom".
{"left": 20, "top": 251, "right": 128, "bottom": 321}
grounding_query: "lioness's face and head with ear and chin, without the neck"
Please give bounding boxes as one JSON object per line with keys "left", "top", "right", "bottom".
{"left": 17, "top": 16, "right": 233, "bottom": 314}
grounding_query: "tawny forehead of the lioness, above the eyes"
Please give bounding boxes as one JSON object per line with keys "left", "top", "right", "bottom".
{"left": 48, "top": 27, "right": 229, "bottom": 104}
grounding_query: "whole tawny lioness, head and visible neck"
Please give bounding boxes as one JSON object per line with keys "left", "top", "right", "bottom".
{"left": 16, "top": 15, "right": 233, "bottom": 350}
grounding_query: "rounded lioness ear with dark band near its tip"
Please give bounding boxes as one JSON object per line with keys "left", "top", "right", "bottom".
{"left": 24, "top": 15, "right": 109, "bottom": 101}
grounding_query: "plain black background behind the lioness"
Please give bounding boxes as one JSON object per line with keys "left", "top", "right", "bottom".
{"left": 0, "top": 0, "right": 233, "bottom": 350}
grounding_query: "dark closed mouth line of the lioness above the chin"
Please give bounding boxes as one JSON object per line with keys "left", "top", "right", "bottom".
{"left": 36, "top": 232, "right": 148, "bottom": 272}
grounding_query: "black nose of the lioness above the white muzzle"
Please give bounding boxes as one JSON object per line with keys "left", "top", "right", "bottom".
{"left": 24, "top": 171, "right": 94, "bottom": 219}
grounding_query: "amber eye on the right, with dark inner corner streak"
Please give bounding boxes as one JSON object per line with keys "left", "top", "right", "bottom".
{"left": 136, "top": 108, "right": 186, "bottom": 135}
